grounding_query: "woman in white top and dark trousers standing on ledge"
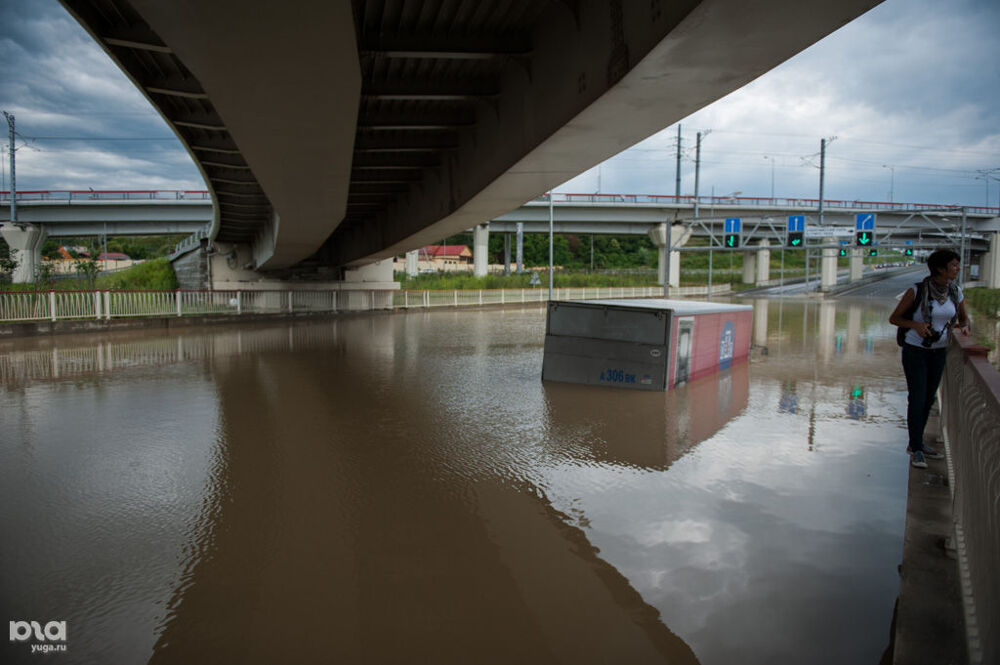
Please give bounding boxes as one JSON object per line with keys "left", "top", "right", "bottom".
{"left": 889, "top": 249, "right": 969, "bottom": 469}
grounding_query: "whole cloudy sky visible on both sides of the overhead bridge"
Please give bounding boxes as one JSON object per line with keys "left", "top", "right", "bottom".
{"left": 0, "top": 0, "right": 1000, "bottom": 206}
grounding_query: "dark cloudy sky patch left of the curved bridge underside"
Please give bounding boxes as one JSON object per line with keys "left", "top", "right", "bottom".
{"left": 0, "top": 0, "right": 204, "bottom": 190}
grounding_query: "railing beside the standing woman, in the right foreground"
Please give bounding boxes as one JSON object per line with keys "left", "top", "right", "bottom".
{"left": 941, "top": 338, "right": 1000, "bottom": 665}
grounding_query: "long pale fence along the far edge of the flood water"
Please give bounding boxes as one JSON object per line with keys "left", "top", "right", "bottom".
{"left": 0, "top": 284, "right": 730, "bottom": 322}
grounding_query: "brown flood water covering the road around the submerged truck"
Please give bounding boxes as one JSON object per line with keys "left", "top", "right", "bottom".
{"left": 0, "top": 300, "right": 907, "bottom": 665}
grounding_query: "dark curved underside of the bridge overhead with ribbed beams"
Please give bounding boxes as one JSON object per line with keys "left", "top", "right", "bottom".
{"left": 62, "top": 0, "right": 878, "bottom": 274}
